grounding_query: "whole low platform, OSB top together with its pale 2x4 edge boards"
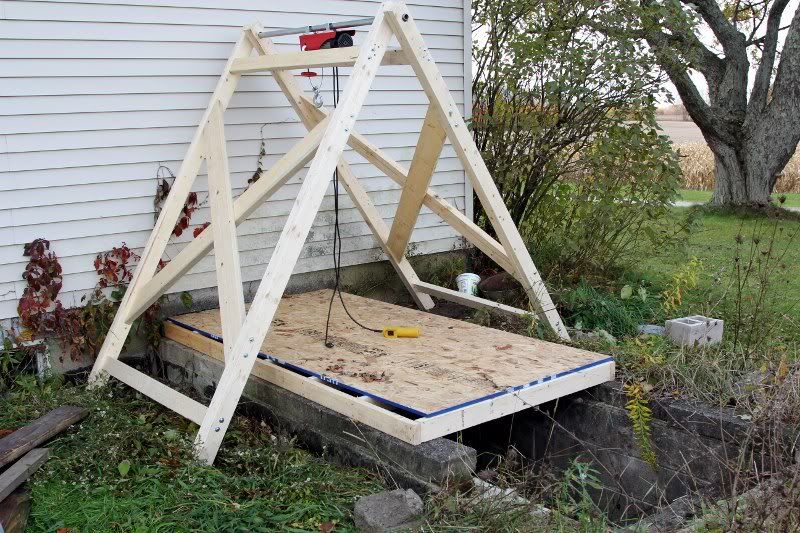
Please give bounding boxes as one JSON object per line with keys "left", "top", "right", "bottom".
{"left": 165, "top": 290, "right": 614, "bottom": 444}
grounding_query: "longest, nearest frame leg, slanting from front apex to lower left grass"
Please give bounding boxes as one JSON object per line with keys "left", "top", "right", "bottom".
{"left": 195, "top": 16, "right": 391, "bottom": 463}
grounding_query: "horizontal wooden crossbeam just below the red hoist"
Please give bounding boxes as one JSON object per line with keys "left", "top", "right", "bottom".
{"left": 231, "top": 46, "right": 408, "bottom": 74}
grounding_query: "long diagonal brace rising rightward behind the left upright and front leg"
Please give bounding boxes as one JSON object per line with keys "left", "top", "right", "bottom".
{"left": 120, "top": 115, "right": 329, "bottom": 322}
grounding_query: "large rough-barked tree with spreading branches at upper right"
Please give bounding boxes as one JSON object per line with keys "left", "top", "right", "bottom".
{"left": 627, "top": 0, "right": 800, "bottom": 205}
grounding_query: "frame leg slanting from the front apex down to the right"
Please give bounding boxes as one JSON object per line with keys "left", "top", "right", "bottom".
{"left": 386, "top": 6, "right": 569, "bottom": 340}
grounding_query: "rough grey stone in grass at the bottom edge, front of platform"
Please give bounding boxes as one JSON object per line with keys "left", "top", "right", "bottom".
{"left": 353, "top": 489, "right": 424, "bottom": 533}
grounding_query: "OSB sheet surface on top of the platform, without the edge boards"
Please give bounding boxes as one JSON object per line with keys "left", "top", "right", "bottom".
{"left": 166, "top": 290, "right": 608, "bottom": 414}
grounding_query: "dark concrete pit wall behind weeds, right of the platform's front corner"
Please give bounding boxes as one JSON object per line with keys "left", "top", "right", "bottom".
{"left": 509, "top": 382, "right": 750, "bottom": 519}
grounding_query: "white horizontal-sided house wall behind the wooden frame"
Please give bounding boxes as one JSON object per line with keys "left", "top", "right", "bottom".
{"left": 0, "top": 0, "right": 471, "bottom": 319}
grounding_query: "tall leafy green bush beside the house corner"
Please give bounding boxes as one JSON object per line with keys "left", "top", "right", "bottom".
{"left": 472, "top": 0, "right": 681, "bottom": 271}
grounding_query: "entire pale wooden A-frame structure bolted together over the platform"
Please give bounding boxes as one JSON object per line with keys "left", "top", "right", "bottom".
{"left": 90, "top": 1, "right": 569, "bottom": 463}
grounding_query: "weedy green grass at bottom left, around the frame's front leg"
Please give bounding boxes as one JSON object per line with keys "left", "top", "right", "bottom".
{"left": 0, "top": 381, "right": 385, "bottom": 532}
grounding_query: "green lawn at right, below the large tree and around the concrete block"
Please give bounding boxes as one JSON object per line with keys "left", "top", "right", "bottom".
{"left": 601, "top": 208, "right": 800, "bottom": 405}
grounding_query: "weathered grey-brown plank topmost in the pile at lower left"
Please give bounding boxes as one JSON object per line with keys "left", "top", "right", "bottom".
{"left": 0, "top": 405, "right": 89, "bottom": 468}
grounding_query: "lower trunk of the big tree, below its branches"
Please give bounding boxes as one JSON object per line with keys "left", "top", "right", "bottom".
{"left": 708, "top": 139, "right": 775, "bottom": 206}
